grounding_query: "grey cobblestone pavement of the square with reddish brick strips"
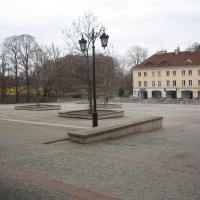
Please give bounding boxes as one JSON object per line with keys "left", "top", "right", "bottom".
{"left": 0, "top": 103, "right": 200, "bottom": 200}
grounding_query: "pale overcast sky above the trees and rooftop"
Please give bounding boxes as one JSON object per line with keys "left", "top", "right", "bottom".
{"left": 0, "top": 0, "right": 200, "bottom": 56}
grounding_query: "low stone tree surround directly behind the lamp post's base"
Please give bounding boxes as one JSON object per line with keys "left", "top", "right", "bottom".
{"left": 58, "top": 110, "right": 124, "bottom": 119}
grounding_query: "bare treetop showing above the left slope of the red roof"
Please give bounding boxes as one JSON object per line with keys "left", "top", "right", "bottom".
{"left": 126, "top": 45, "right": 148, "bottom": 67}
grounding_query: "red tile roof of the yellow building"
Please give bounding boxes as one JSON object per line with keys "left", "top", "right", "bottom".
{"left": 136, "top": 51, "right": 200, "bottom": 67}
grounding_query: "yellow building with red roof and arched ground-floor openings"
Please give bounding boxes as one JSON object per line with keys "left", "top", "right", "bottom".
{"left": 133, "top": 46, "right": 200, "bottom": 99}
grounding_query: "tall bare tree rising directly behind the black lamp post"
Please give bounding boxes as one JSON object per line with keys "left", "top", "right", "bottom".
{"left": 63, "top": 12, "right": 112, "bottom": 113}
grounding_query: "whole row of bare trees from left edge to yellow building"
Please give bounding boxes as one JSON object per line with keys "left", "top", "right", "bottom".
{"left": 0, "top": 13, "right": 148, "bottom": 109}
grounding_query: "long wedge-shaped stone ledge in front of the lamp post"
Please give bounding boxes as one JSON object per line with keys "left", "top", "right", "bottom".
{"left": 68, "top": 117, "right": 163, "bottom": 144}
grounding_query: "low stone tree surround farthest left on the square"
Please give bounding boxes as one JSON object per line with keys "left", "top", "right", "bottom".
{"left": 15, "top": 104, "right": 61, "bottom": 111}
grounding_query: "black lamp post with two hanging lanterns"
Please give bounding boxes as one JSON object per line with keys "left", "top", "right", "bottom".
{"left": 79, "top": 27, "right": 109, "bottom": 127}
